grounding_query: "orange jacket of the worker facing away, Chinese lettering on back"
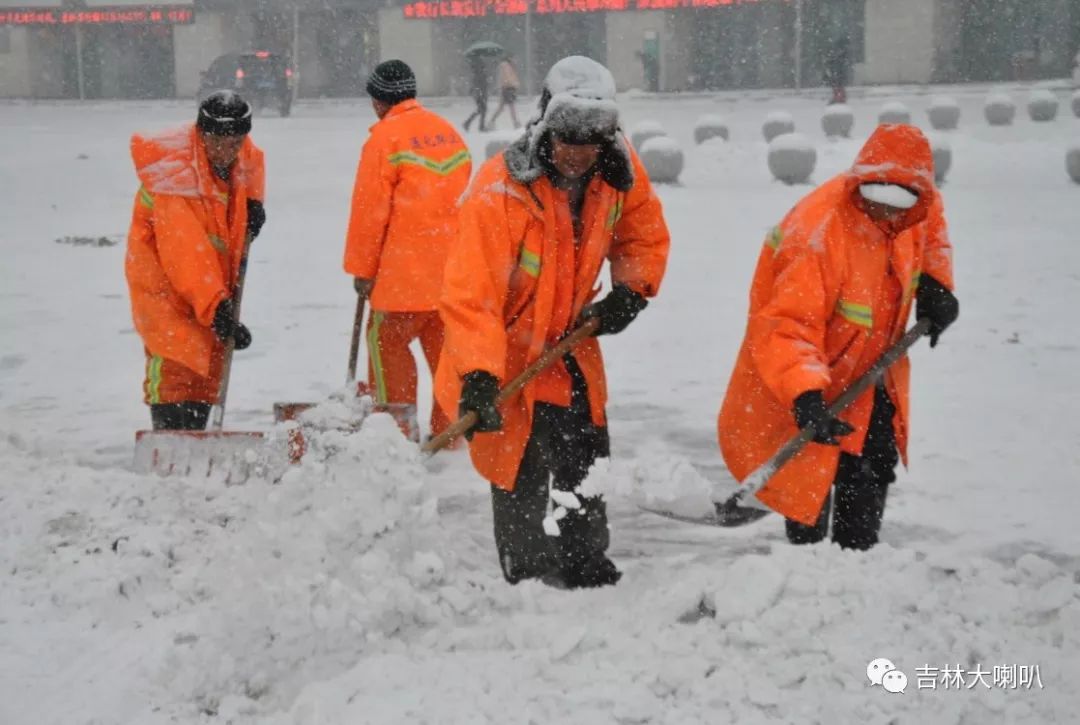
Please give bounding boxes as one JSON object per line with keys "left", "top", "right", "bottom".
{"left": 345, "top": 99, "right": 472, "bottom": 312}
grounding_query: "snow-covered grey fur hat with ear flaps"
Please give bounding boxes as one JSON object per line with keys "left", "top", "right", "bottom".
{"left": 504, "top": 55, "right": 634, "bottom": 191}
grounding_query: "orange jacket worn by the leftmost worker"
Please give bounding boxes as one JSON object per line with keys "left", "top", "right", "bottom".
{"left": 125, "top": 123, "right": 264, "bottom": 384}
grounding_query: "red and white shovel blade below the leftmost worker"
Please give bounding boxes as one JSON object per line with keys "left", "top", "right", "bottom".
{"left": 134, "top": 430, "right": 265, "bottom": 482}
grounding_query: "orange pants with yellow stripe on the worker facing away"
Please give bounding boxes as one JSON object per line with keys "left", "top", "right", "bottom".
{"left": 367, "top": 310, "right": 450, "bottom": 435}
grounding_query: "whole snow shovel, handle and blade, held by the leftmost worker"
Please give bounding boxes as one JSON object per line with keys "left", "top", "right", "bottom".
{"left": 135, "top": 236, "right": 265, "bottom": 481}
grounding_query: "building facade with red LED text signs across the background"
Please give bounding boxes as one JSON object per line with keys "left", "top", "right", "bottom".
{"left": 0, "top": 0, "right": 1080, "bottom": 98}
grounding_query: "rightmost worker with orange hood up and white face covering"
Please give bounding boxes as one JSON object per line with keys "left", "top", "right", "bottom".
{"left": 718, "top": 125, "right": 959, "bottom": 549}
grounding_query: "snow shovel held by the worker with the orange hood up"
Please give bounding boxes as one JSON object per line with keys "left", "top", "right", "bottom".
{"left": 646, "top": 319, "right": 930, "bottom": 528}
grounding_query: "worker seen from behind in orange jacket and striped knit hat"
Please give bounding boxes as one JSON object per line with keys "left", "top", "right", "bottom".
{"left": 345, "top": 61, "right": 472, "bottom": 435}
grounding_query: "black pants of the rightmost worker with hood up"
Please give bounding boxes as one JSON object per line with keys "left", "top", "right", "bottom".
{"left": 787, "top": 386, "right": 900, "bottom": 550}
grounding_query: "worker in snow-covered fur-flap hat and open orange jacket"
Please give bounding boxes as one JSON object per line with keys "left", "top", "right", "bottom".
{"left": 435, "top": 56, "right": 670, "bottom": 588}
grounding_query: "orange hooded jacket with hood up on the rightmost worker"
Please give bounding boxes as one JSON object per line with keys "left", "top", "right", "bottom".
{"left": 718, "top": 125, "right": 953, "bottom": 525}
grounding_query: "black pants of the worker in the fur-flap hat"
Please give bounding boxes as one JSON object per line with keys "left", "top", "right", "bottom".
{"left": 491, "top": 358, "right": 621, "bottom": 588}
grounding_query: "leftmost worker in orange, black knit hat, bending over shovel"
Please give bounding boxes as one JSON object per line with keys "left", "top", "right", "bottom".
{"left": 125, "top": 91, "right": 266, "bottom": 430}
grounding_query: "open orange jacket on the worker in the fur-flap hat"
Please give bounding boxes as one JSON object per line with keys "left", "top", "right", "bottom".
{"left": 435, "top": 144, "right": 670, "bottom": 491}
